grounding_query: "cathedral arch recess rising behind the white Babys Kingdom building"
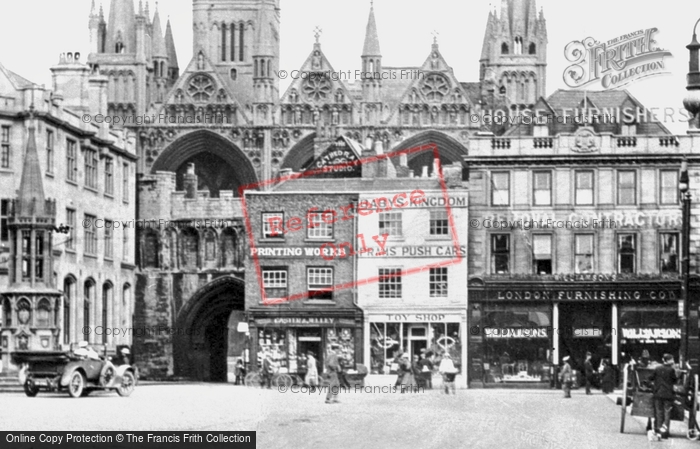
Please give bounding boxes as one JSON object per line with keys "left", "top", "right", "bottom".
{"left": 391, "top": 130, "right": 468, "bottom": 176}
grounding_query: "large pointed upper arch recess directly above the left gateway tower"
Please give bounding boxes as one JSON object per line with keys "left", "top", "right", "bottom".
{"left": 151, "top": 130, "right": 258, "bottom": 198}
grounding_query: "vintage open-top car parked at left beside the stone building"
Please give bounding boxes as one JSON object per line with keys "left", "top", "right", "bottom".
{"left": 12, "top": 345, "right": 138, "bottom": 398}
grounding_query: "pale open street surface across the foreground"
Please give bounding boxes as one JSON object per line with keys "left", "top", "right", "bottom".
{"left": 0, "top": 384, "right": 697, "bottom": 448}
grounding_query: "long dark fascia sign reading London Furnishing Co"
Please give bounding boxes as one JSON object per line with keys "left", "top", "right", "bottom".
{"left": 489, "top": 289, "right": 676, "bottom": 301}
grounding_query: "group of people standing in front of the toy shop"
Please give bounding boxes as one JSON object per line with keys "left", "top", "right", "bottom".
{"left": 394, "top": 349, "right": 458, "bottom": 394}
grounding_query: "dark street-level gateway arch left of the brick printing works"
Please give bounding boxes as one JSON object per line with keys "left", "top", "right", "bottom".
{"left": 173, "top": 276, "right": 246, "bottom": 382}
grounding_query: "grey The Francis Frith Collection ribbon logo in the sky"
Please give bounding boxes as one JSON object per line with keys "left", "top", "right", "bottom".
{"left": 564, "top": 28, "right": 672, "bottom": 90}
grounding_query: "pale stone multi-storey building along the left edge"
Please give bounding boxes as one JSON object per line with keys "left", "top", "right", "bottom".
{"left": 0, "top": 53, "right": 136, "bottom": 370}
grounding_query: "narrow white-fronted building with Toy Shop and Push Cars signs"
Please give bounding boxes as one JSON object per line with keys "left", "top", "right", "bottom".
{"left": 356, "top": 154, "right": 468, "bottom": 386}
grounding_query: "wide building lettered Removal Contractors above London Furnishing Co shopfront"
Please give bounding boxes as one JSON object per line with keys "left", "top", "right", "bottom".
{"left": 465, "top": 91, "right": 698, "bottom": 386}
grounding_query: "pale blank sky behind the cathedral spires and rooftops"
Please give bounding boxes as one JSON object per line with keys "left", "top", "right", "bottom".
{"left": 0, "top": 0, "right": 700, "bottom": 134}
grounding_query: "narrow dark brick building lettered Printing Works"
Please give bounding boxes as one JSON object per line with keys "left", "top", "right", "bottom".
{"left": 244, "top": 138, "right": 363, "bottom": 373}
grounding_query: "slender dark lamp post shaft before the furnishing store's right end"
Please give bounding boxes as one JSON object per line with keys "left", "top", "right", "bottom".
{"left": 678, "top": 160, "right": 690, "bottom": 367}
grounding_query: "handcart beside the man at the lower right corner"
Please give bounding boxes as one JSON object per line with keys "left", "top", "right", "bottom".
{"left": 620, "top": 364, "right": 700, "bottom": 440}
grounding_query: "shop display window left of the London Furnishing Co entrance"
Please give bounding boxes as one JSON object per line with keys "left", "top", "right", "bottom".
{"left": 482, "top": 304, "right": 552, "bottom": 384}
